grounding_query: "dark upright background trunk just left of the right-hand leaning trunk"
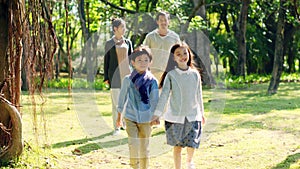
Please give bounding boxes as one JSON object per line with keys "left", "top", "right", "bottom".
{"left": 233, "top": 0, "right": 250, "bottom": 77}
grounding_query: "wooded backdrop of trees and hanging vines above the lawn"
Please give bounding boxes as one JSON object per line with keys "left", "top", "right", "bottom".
{"left": 0, "top": 0, "right": 300, "bottom": 162}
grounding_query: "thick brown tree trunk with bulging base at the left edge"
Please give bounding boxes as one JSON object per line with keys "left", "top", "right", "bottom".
{"left": 0, "top": 1, "right": 25, "bottom": 162}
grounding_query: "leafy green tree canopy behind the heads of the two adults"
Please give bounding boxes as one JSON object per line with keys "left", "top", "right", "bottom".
{"left": 49, "top": 0, "right": 300, "bottom": 80}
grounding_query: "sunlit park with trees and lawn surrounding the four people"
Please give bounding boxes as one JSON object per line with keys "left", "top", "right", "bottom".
{"left": 0, "top": 0, "right": 300, "bottom": 169}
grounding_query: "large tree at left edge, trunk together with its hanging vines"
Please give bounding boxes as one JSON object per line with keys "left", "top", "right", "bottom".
{"left": 0, "top": 0, "right": 56, "bottom": 162}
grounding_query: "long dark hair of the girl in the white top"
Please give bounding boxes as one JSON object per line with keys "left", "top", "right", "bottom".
{"left": 159, "top": 42, "right": 194, "bottom": 88}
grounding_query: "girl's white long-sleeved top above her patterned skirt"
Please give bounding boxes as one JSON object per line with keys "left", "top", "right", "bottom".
{"left": 154, "top": 68, "right": 204, "bottom": 124}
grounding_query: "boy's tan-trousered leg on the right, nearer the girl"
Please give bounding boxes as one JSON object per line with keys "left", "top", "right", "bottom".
{"left": 138, "top": 123, "right": 151, "bottom": 169}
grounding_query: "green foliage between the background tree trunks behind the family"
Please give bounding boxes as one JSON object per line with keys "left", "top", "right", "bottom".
{"left": 52, "top": 0, "right": 300, "bottom": 80}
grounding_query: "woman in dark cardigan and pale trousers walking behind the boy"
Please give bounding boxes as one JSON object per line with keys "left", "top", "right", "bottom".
{"left": 104, "top": 18, "right": 132, "bottom": 135}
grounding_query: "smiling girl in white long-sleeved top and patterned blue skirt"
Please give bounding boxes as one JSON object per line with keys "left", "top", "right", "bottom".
{"left": 152, "top": 42, "right": 205, "bottom": 169}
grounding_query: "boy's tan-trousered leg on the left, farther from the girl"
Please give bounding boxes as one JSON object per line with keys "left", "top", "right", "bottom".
{"left": 125, "top": 119, "right": 140, "bottom": 169}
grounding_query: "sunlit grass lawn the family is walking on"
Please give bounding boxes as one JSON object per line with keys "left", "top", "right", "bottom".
{"left": 7, "top": 83, "right": 300, "bottom": 169}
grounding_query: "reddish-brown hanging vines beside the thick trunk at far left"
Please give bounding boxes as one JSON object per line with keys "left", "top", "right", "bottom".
{"left": 24, "top": 0, "right": 57, "bottom": 143}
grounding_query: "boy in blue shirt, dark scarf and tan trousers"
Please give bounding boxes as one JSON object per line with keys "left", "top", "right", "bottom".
{"left": 117, "top": 46, "right": 159, "bottom": 169}
